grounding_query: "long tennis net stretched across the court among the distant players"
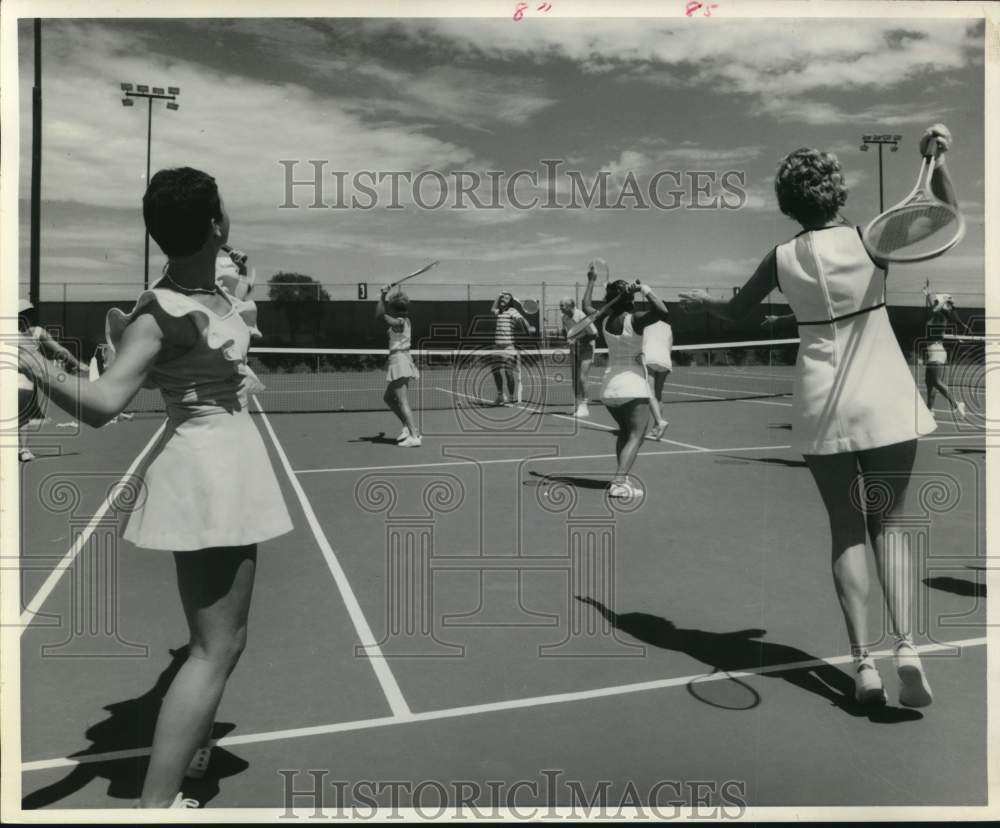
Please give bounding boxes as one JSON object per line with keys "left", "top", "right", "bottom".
{"left": 119, "top": 339, "right": 798, "bottom": 413}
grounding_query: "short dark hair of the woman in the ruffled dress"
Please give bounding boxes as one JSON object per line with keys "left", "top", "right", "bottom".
{"left": 142, "top": 167, "right": 222, "bottom": 256}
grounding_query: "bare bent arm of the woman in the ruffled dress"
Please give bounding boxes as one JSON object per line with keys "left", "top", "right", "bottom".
{"left": 21, "top": 313, "right": 163, "bottom": 428}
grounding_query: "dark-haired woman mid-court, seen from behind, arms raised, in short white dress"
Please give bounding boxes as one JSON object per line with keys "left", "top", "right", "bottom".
{"left": 582, "top": 267, "right": 667, "bottom": 498}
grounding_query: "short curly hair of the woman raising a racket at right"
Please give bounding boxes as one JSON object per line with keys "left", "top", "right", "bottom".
{"left": 774, "top": 147, "right": 847, "bottom": 223}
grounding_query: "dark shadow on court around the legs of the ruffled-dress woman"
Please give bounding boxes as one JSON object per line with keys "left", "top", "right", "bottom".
{"left": 21, "top": 646, "right": 250, "bottom": 810}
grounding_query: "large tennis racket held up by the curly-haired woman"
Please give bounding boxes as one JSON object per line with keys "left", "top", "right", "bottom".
{"left": 861, "top": 141, "right": 965, "bottom": 262}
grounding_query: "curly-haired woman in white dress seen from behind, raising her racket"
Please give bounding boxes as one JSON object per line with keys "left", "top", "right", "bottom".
{"left": 682, "top": 124, "right": 961, "bottom": 707}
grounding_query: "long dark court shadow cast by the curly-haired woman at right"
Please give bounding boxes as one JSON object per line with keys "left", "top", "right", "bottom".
{"left": 576, "top": 595, "right": 923, "bottom": 724}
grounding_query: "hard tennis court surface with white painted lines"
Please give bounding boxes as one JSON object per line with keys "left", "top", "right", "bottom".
{"left": 21, "top": 346, "right": 987, "bottom": 816}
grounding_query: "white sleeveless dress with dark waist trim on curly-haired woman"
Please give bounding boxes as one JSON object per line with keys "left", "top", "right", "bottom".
{"left": 775, "top": 225, "right": 937, "bottom": 454}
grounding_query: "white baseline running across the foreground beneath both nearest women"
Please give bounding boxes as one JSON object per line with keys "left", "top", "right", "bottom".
{"left": 21, "top": 638, "right": 986, "bottom": 773}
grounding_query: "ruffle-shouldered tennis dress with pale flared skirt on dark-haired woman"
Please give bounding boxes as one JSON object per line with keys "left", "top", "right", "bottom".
{"left": 106, "top": 288, "right": 292, "bottom": 551}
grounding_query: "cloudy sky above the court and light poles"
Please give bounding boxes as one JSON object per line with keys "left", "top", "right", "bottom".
{"left": 13, "top": 15, "right": 984, "bottom": 301}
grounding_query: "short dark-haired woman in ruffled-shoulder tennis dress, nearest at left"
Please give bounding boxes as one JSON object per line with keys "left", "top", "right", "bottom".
{"left": 19, "top": 167, "right": 292, "bottom": 808}
